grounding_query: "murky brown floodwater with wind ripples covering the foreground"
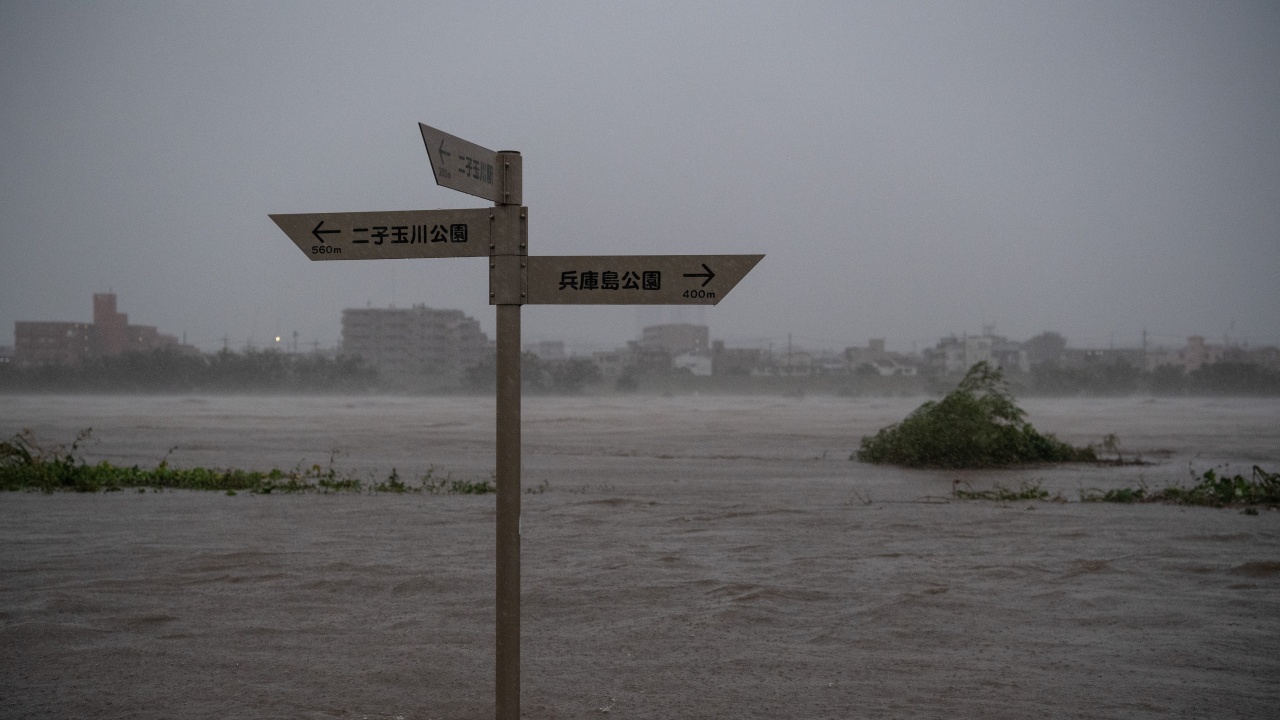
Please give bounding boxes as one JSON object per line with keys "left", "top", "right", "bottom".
{"left": 0, "top": 396, "right": 1280, "bottom": 719}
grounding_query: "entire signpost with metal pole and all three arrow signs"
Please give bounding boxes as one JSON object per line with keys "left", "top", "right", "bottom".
{"left": 271, "top": 123, "right": 764, "bottom": 720}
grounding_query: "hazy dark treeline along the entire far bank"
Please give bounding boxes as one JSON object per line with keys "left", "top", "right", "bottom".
{"left": 0, "top": 348, "right": 1280, "bottom": 396}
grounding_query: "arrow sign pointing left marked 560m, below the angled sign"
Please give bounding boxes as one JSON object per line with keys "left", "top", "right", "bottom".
{"left": 271, "top": 208, "right": 493, "bottom": 260}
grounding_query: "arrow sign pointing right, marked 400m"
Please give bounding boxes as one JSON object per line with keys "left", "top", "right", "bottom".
{"left": 526, "top": 255, "right": 764, "bottom": 305}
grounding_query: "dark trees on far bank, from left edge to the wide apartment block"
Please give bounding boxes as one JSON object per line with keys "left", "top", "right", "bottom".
{"left": 0, "top": 348, "right": 378, "bottom": 392}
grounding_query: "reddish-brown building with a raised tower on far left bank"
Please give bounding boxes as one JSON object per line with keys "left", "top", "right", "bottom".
{"left": 13, "top": 292, "right": 178, "bottom": 366}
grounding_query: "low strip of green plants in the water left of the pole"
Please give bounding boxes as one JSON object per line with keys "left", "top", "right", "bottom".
{"left": 0, "top": 430, "right": 499, "bottom": 495}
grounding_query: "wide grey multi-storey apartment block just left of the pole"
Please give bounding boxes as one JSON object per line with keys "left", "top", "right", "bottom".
{"left": 342, "top": 305, "right": 490, "bottom": 379}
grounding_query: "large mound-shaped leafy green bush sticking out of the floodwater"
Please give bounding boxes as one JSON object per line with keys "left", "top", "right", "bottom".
{"left": 854, "top": 363, "right": 1097, "bottom": 469}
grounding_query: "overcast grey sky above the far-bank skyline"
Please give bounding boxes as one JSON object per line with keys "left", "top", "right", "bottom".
{"left": 0, "top": 0, "right": 1280, "bottom": 350}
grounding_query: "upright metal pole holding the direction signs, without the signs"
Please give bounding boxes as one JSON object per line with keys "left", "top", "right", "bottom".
{"left": 489, "top": 152, "right": 529, "bottom": 720}
